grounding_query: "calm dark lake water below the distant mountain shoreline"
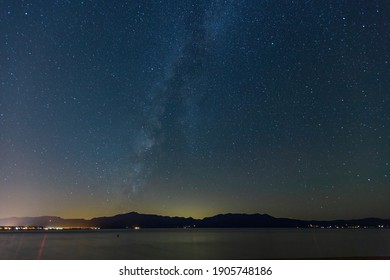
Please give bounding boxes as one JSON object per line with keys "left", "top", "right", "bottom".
{"left": 0, "top": 229, "right": 390, "bottom": 260}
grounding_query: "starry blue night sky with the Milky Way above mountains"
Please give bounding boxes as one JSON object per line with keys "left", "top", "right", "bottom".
{"left": 0, "top": 0, "right": 390, "bottom": 219}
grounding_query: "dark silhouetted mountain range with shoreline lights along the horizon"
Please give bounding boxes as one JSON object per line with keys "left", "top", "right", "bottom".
{"left": 0, "top": 212, "right": 390, "bottom": 229}
